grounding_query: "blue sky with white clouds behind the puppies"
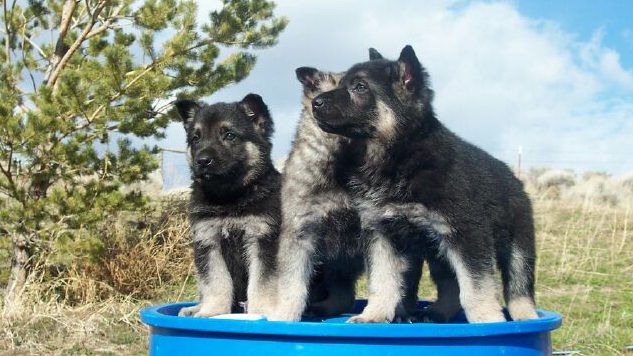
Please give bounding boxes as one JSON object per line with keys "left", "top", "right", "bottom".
{"left": 160, "top": 0, "right": 633, "bottom": 186}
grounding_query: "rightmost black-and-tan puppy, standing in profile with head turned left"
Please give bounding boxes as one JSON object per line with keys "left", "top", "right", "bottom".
{"left": 312, "top": 46, "right": 537, "bottom": 323}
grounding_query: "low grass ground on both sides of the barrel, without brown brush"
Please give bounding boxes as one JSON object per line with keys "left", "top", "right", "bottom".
{"left": 0, "top": 199, "right": 633, "bottom": 355}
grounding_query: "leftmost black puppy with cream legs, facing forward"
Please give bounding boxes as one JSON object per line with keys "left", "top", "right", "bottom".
{"left": 175, "top": 94, "right": 281, "bottom": 317}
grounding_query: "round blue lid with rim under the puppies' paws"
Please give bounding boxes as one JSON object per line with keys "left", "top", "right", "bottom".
{"left": 141, "top": 301, "right": 562, "bottom": 338}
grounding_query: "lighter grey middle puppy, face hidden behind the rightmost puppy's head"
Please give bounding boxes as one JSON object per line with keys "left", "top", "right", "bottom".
{"left": 269, "top": 67, "right": 363, "bottom": 321}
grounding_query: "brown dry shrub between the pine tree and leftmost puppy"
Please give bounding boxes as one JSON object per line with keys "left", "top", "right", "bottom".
{"left": 27, "top": 200, "right": 193, "bottom": 305}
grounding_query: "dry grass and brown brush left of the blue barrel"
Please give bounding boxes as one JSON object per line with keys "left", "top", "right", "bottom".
{"left": 0, "top": 201, "right": 194, "bottom": 355}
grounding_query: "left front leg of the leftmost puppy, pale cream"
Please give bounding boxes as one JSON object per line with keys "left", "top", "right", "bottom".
{"left": 178, "top": 221, "right": 233, "bottom": 317}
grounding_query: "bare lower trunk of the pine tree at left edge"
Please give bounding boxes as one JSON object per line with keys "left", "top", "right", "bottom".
{"left": 3, "top": 234, "right": 31, "bottom": 315}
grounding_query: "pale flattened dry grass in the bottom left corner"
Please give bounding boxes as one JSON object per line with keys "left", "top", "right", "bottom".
{"left": 0, "top": 298, "right": 147, "bottom": 355}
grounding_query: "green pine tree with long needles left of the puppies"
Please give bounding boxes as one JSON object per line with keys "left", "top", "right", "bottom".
{"left": 0, "top": 0, "right": 287, "bottom": 310}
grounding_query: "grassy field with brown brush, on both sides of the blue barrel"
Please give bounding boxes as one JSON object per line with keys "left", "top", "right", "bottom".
{"left": 0, "top": 193, "right": 633, "bottom": 355}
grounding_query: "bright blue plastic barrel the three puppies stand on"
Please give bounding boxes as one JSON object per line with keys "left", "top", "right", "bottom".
{"left": 141, "top": 301, "right": 562, "bottom": 356}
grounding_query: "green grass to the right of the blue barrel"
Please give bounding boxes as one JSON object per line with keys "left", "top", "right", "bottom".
{"left": 535, "top": 202, "right": 633, "bottom": 355}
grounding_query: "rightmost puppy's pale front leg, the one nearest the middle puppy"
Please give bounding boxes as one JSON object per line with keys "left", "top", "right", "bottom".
{"left": 347, "top": 231, "right": 407, "bottom": 323}
